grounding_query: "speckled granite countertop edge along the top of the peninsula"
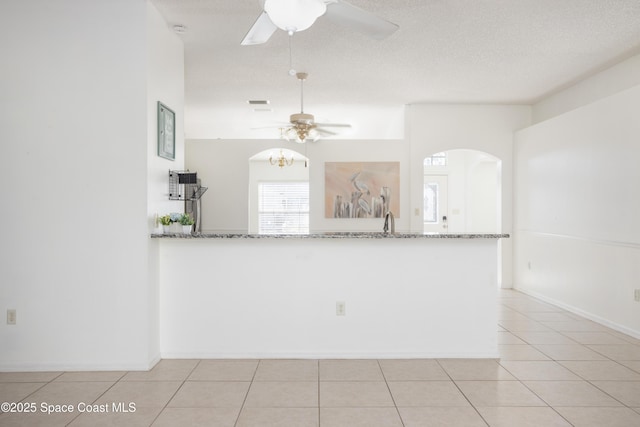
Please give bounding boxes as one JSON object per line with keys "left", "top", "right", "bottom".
{"left": 151, "top": 232, "right": 510, "bottom": 239}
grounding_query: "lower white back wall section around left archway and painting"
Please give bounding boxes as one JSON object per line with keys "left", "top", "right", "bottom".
{"left": 185, "top": 140, "right": 409, "bottom": 233}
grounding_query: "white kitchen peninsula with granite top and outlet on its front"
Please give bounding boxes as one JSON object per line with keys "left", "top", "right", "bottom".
{"left": 152, "top": 233, "right": 509, "bottom": 358}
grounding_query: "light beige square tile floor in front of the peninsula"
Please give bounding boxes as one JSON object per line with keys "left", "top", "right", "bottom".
{"left": 0, "top": 290, "right": 640, "bottom": 427}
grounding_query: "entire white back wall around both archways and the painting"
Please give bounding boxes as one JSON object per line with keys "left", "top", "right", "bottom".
{"left": 185, "top": 105, "right": 530, "bottom": 241}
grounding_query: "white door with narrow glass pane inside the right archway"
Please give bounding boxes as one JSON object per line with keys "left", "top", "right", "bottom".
{"left": 423, "top": 175, "right": 449, "bottom": 233}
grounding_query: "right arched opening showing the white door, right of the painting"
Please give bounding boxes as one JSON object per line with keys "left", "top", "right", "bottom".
{"left": 423, "top": 149, "right": 502, "bottom": 233}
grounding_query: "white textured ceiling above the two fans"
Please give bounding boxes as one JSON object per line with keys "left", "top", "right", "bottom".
{"left": 152, "top": 0, "right": 640, "bottom": 138}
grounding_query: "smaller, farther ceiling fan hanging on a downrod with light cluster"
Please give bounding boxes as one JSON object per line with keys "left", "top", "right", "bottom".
{"left": 280, "top": 73, "right": 351, "bottom": 144}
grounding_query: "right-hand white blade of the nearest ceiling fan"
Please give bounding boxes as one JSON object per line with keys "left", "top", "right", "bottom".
{"left": 325, "top": 0, "right": 399, "bottom": 40}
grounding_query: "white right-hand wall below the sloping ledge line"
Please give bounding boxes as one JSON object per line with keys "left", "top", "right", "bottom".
{"left": 515, "top": 86, "right": 640, "bottom": 337}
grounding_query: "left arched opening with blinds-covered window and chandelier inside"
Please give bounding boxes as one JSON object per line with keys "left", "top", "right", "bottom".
{"left": 248, "top": 148, "right": 309, "bottom": 234}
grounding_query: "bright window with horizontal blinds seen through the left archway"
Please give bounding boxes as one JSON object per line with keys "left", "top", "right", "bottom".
{"left": 258, "top": 181, "right": 309, "bottom": 234}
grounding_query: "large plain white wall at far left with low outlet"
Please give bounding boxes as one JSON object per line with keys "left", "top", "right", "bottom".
{"left": 0, "top": 0, "right": 182, "bottom": 370}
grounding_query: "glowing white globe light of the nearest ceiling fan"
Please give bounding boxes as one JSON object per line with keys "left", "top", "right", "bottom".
{"left": 264, "top": 0, "right": 327, "bottom": 34}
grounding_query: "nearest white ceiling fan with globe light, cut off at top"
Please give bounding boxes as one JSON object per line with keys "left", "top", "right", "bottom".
{"left": 241, "top": 0, "right": 398, "bottom": 46}
